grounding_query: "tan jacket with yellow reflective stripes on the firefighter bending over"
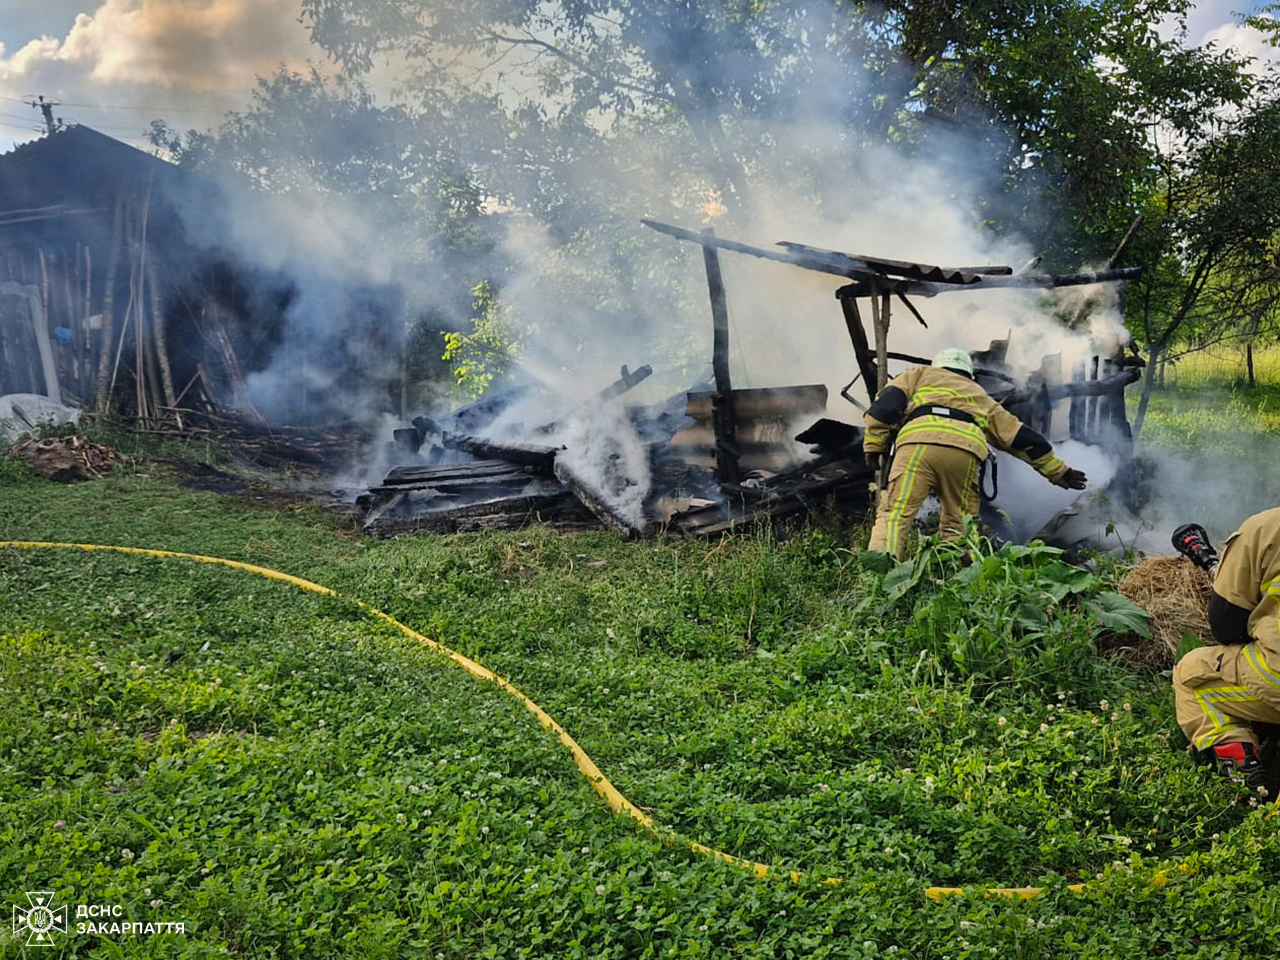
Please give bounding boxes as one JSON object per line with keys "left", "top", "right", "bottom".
{"left": 863, "top": 366, "right": 1069, "bottom": 483}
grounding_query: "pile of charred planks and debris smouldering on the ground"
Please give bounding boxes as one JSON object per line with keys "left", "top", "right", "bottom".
{"left": 357, "top": 367, "right": 869, "bottom": 536}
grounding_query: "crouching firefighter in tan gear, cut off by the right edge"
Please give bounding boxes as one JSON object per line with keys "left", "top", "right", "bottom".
{"left": 1174, "top": 507, "right": 1280, "bottom": 799}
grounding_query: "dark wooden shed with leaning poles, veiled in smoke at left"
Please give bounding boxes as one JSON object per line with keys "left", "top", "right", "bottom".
{"left": 0, "top": 125, "right": 403, "bottom": 429}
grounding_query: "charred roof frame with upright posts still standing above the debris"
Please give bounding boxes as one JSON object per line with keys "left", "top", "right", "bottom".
{"left": 640, "top": 219, "right": 1142, "bottom": 484}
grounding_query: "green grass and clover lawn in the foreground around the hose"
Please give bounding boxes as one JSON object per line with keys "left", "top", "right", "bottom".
{"left": 0, "top": 461, "right": 1280, "bottom": 957}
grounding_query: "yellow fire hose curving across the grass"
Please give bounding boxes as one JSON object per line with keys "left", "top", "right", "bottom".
{"left": 0, "top": 540, "right": 1188, "bottom": 900}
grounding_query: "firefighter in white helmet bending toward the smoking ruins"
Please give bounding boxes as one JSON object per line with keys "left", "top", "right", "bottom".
{"left": 863, "top": 347, "right": 1085, "bottom": 559}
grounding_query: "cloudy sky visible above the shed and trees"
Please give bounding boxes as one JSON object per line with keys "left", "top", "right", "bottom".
{"left": 0, "top": 0, "right": 1276, "bottom": 152}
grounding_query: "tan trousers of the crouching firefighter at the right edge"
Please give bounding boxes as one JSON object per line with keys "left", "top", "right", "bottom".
{"left": 1174, "top": 643, "right": 1280, "bottom": 750}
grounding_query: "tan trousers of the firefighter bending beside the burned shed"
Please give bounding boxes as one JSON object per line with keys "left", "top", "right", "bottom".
{"left": 867, "top": 443, "right": 982, "bottom": 559}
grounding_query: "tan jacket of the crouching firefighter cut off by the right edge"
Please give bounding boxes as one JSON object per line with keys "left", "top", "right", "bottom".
{"left": 1213, "top": 507, "right": 1280, "bottom": 670}
